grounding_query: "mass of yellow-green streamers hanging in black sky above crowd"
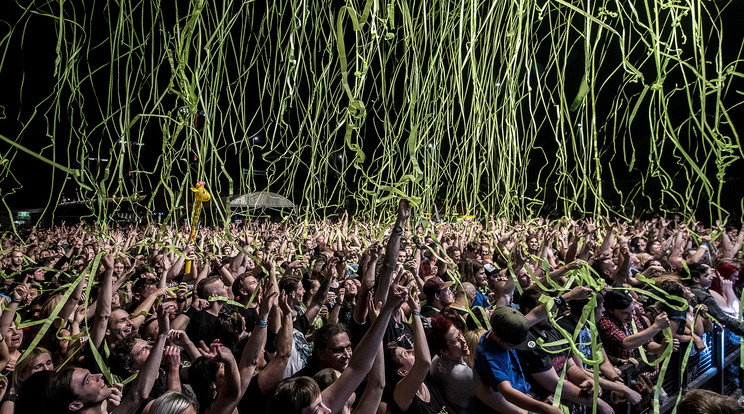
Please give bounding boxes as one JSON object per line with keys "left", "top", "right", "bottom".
{"left": 0, "top": 0, "right": 744, "bottom": 226}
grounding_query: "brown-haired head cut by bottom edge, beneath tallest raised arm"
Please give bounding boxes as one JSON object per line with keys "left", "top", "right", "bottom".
{"left": 266, "top": 377, "right": 331, "bottom": 414}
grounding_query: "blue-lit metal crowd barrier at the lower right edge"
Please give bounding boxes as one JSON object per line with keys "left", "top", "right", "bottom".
{"left": 615, "top": 326, "right": 744, "bottom": 414}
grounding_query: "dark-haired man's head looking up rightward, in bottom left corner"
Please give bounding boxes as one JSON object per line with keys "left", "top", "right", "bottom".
{"left": 41, "top": 367, "right": 111, "bottom": 413}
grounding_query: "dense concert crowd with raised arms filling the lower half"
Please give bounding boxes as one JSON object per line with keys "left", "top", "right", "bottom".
{"left": 0, "top": 200, "right": 744, "bottom": 414}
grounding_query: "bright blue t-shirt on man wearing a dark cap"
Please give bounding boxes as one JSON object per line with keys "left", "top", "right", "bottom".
{"left": 475, "top": 331, "right": 530, "bottom": 394}
